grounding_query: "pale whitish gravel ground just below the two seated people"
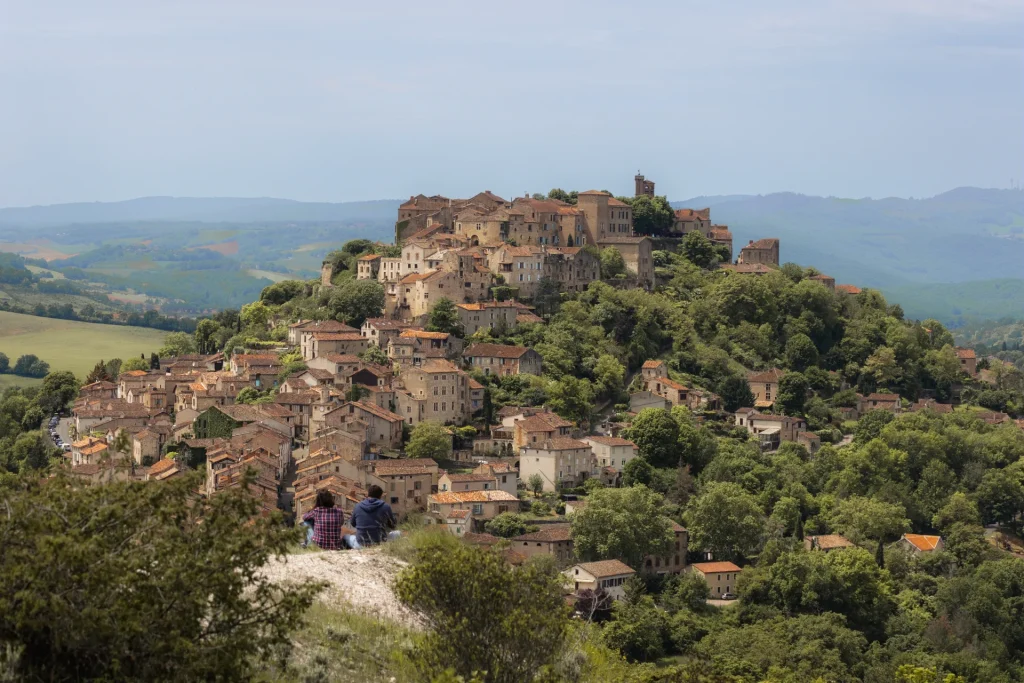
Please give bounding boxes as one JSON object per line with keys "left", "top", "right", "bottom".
{"left": 264, "top": 549, "right": 422, "bottom": 629}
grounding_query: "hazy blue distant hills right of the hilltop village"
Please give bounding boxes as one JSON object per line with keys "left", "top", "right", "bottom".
{"left": 673, "top": 187, "right": 1024, "bottom": 288}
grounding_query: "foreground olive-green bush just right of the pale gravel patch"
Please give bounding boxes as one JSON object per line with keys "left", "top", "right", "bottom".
{"left": 395, "top": 541, "right": 568, "bottom": 683}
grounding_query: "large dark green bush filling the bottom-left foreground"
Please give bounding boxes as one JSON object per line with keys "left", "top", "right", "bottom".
{"left": 0, "top": 474, "right": 321, "bottom": 682}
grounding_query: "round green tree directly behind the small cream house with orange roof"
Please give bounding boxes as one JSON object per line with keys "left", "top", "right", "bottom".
{"left": 686, "top": 481, "right": 765, "bottom": 559}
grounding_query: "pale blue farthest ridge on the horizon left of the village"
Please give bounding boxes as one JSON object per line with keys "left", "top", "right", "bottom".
{"left": 0, "top": 197, "right": 401, "bottom": 227}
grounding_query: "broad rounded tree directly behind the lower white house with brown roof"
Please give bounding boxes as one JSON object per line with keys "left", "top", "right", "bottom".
{"left": 570, "top": 485, "right": 675, "bottom": 569}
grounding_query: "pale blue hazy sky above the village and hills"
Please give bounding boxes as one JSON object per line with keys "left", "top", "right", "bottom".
{"left": 0, "top": 0, "right": 1024, "bottom": 206}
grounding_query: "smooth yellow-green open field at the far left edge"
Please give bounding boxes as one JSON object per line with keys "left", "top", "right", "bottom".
{"left": 0, "top": 311, "right": 167, "bottom": 386}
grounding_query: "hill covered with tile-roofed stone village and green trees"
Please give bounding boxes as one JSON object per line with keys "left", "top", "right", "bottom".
{"left": 12, "top": 175, "right": 1024, "bottom": 680}
